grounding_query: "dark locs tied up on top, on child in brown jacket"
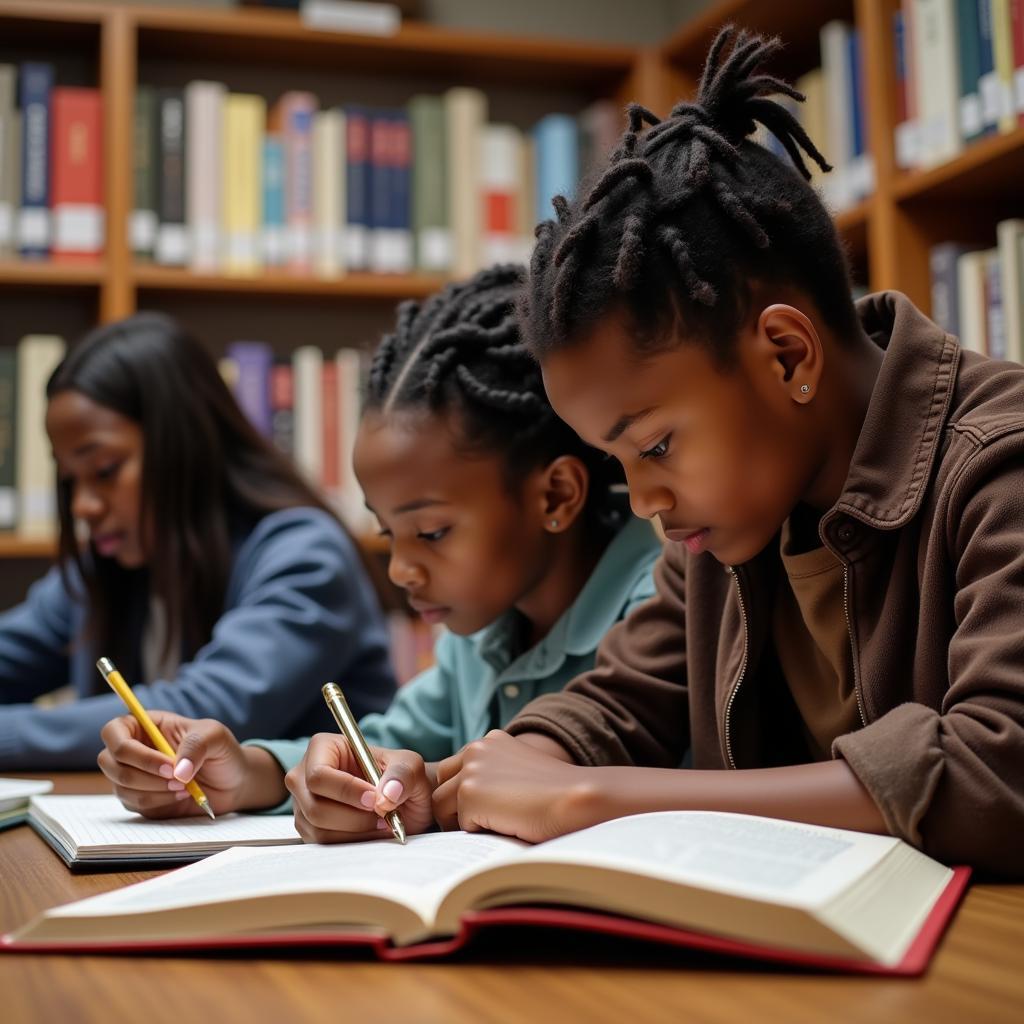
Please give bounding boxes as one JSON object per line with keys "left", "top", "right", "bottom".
{"left": 520, "top": 26, "right": 857, "bottom": 367}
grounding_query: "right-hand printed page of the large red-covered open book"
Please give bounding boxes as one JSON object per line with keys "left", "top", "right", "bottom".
{"left": 523, "top": 811, "right": 899, "bottom": 907}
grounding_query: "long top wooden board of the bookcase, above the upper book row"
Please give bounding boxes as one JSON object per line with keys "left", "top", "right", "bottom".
{"left": 132, "top": 8, "right": 637, "bottom": 89}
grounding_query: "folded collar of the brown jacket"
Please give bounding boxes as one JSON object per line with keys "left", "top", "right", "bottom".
{"left": 822, "top": 292, "right": 961, "bottom": 529}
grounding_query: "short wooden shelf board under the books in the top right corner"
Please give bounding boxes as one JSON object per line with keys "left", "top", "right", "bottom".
{"left": 893, "top": 127, "right": 1024, "bottom": 204}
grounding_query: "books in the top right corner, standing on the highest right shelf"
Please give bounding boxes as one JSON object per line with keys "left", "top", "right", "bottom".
{"left": 893, "top": 0, "right": 1024, "bottom": 168}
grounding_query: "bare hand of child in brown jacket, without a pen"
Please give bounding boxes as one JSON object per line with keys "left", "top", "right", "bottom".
{"left": 434, "top": 729, "right": 599, "bottom": 843}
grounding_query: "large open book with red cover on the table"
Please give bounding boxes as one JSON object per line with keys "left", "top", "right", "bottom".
{"left": 3, "top": 811, "right": 968, "bottom": 974}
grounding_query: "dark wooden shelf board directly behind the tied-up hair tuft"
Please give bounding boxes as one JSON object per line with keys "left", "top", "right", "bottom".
{"left": 663, "top": 0, "right": 854, "bottom": 78}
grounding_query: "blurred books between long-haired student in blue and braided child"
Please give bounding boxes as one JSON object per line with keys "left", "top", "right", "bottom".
{"left": 220, "top": 341, "right": 376, "bottom": 534}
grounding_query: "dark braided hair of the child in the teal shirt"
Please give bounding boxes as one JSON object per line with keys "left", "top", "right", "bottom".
{"left": 366, "top": 264, "right": 626, "bottom": 529}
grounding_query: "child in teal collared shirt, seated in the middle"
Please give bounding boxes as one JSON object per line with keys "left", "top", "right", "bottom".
{"left": 99, "top": 266, "right": 660, "bottom": 842}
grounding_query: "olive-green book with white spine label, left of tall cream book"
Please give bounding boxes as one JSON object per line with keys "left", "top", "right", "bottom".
{"left": 409, "top": 95, "right": 452, "bottom": 272}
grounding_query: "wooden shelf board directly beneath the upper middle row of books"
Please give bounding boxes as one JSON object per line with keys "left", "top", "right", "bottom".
{"left": 132, "top": 265, "right": 446, "bottom": 302}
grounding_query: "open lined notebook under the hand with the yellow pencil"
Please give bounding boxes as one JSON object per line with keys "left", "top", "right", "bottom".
{"left": 29, "top": 796, "right": 302, "bottom": 871}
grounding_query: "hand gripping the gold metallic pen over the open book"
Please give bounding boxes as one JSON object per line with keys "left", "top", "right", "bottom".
{"left": 285, "top": 732, "right": 434, "bottom": 843}
